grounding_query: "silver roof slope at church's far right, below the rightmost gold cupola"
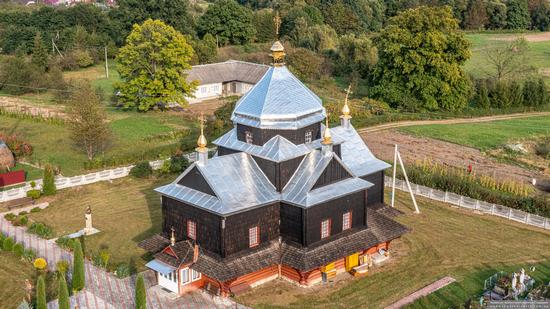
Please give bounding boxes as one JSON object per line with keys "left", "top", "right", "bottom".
{"left": 330, "top": 124, "right": 391, "bottom": 176}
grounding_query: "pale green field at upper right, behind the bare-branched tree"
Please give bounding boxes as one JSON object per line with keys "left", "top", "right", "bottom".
{"left": 464, "top": 33, "right": 550, "bottom": 82}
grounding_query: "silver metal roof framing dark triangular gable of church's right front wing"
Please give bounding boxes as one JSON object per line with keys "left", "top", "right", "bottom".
{"left": 281, "top": 150, "right": 374, "bottom": 207}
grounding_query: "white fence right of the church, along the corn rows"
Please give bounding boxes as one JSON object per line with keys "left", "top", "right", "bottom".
{"left": 385, "top": 177, "right": 550, "bottom": 229}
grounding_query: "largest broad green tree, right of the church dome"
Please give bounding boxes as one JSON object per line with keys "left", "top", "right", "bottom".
{"left": 371, "top": 6, "right": 472, "bottom": 110}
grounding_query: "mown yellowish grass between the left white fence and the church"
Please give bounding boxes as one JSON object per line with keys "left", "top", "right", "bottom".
{"left": 29, "top": 176, "right": 166, "bottom": 270}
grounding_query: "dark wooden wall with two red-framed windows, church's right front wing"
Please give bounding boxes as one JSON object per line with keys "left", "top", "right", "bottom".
{"left": 304, "top": 191, "right": 366, "bottom": 246}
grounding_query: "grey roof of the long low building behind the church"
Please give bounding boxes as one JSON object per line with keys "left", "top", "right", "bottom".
{"left": 187, "top": 60, "right": 269, "bottom": 85}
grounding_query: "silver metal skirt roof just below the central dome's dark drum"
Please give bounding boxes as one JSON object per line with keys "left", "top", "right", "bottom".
{"left": 213, "top": 126, "right": 344, "bottom": 162}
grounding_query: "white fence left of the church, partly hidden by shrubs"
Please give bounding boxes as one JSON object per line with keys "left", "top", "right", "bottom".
{"left": 0, "top": 152, "right": 197, "bottom": 203}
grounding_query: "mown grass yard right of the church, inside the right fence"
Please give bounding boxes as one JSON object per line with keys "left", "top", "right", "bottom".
{"left": 238, "top": 192, "right": 550, "bottom": 308}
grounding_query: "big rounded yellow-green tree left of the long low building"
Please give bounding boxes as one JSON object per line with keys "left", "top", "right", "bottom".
{"left": 117, "top": 20, "right": 196, "bottom": 111}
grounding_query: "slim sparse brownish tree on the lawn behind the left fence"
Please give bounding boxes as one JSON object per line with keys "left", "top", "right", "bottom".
{"left": 68, "top": 82, "right": 110, "bottom": 160}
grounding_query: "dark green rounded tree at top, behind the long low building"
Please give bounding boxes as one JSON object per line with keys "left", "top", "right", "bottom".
{"left": 197, "top": 0, "right": 256, "bottom": 45}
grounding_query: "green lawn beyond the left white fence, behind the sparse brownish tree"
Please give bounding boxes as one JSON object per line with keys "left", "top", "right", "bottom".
{"left": 0, "top": 111, "right": 197, "bottom": 177}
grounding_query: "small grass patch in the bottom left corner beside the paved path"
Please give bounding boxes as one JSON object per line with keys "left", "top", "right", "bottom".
{"left": 0, "top": 251, "right": 35, "bottom": 309}
